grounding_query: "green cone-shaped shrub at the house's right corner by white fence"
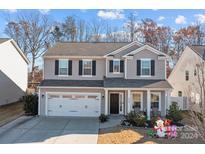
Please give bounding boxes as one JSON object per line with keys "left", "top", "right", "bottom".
{"left": 167, "top": 102, "right": 183, "bottom": 123}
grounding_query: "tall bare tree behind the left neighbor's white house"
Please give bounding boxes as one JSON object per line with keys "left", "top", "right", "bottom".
{"left": 5, "top": 14, "right": 52, "bottom": 86}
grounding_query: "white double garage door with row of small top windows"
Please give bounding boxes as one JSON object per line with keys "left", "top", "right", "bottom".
{"left": 47, "top": 93, "right": 100, "bottom": 117}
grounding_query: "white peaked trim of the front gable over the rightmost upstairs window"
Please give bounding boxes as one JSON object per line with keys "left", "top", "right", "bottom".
{"left": 123, "top": 44, "right": 169, "bottom": 58}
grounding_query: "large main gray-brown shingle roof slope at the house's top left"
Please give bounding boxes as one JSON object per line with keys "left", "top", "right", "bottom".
{"left": 44, "top": 42, "right": 129, "bottom": 57}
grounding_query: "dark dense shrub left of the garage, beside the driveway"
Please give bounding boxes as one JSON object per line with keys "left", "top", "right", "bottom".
{"left": 22, "top": 94, "right": 38, "bottom": 115}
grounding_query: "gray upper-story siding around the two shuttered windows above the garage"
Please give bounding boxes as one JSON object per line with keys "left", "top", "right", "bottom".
{"left": 44, "top": 58, "right": 105, "bottom": 80}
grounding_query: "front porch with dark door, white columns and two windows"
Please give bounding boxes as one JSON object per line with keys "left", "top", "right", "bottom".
{"left": 105, "top": 88, "right": 170, "bottom": 120}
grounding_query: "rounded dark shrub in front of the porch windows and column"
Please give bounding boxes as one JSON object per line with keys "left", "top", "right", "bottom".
{"left": 125, "top": 112, "right": 146, "bottom": 127}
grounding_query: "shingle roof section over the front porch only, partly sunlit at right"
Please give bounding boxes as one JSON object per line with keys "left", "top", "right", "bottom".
{"left": 104, "top": 78, "right": 172, "bottom": 88}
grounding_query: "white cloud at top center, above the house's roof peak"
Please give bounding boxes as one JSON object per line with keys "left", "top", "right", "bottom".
{"left": 97, "top": 10, "right": 125, "bottom": 20}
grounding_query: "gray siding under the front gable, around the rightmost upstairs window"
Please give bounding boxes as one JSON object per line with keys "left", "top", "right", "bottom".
{"left": 127, "top": 50, "right": 165, "bottom": 79}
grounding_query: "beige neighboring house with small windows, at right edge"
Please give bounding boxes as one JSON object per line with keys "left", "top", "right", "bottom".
{"left": 168, "top": 45, "right": 205, "bottom": 109}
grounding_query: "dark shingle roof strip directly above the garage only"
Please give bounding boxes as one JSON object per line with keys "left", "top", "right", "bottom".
{"left": 39, "top": 80, "right": 103, "bottom": 87}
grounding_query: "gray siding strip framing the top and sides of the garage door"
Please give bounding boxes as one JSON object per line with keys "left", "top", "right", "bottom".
{"left": 39, "top": 88, "right": 105, "bottom": 116}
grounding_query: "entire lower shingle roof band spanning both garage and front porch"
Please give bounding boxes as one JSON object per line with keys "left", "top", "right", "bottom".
{"left": 40, "top": 78, "right": 172, "bottom": 88}
